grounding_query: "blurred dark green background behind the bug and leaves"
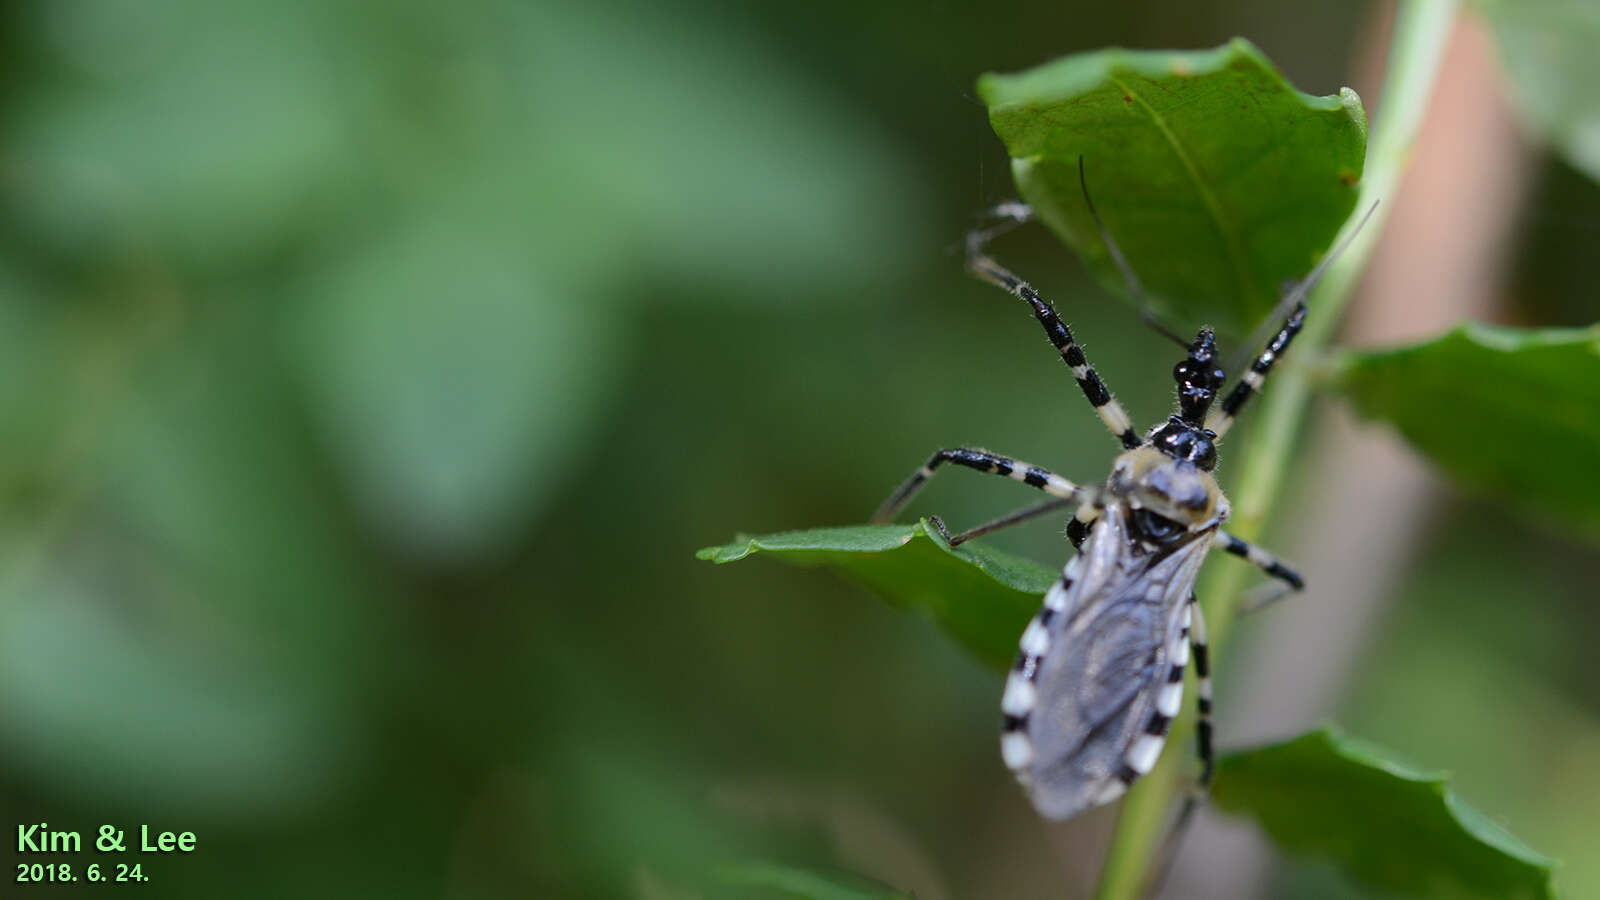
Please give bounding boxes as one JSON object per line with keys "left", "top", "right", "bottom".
{"left": 0, "top": 0, "right": 1600, "bottom": 898}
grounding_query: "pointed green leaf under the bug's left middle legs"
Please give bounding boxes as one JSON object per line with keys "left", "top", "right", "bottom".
{"left": 696, "top": 519, "right": 1058, "bottom": 669}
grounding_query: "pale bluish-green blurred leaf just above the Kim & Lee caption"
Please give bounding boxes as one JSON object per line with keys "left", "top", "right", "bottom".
{"left": 0, "top": 563, "right": 347, "bottom": 822}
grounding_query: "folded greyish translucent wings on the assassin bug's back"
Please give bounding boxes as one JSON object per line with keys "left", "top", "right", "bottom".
{"left": 1026, "top": 506, "right": 1211, "bottom": 818}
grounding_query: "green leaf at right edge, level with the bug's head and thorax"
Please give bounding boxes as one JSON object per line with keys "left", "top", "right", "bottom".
{"left": 1336, "top": 323, "right": 1600, "bottom": 538}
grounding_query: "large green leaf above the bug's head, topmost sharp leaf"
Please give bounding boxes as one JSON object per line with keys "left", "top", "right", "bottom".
{"left": 978, "top": 38, "right": 1366, "bottom": 333}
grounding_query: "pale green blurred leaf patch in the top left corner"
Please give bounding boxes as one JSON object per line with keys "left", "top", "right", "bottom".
{"left": 8, "top": 0, "right": 350, "bottom": 267}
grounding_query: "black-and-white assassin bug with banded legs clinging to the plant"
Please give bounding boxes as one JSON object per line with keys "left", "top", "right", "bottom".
{"left": 874, "top": 159, "right": 1371, "bottom": 820}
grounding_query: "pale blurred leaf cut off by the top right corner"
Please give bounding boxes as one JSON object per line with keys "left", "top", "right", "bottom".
{"left": 1475, "top": 0, "right": 1600, "bottom": 179}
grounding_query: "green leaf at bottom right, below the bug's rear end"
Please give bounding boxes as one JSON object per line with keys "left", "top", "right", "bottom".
{"left": 1211, "top": 725, "right": 1555, "bottom": 900}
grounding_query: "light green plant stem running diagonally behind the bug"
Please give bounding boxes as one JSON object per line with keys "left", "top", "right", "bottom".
{"left": 1094, "top": 0, "right": 1456, "bottom": 900}
